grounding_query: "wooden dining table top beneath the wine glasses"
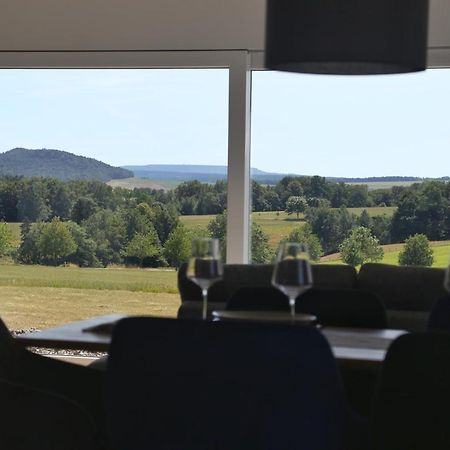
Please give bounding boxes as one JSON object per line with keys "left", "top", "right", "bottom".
{"left": 15, "top": 314, "right": 406, "bottom": 366}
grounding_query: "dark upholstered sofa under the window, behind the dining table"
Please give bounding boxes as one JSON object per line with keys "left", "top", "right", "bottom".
{"left": 178, "top": 263, "right": 446, "bottom": 331}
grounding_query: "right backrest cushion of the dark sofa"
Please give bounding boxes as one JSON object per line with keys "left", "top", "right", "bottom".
{"left": 358, "top": 263, "right": 446, "bottom": 312}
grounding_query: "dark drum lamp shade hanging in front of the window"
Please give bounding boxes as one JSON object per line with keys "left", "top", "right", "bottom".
{"left": 265, "top": 0, "right": 428, "bottom": 75}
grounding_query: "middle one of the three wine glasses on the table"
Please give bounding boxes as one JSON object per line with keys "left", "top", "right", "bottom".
{"left": 272, "top": 242, "right": 313, "bottom": 321}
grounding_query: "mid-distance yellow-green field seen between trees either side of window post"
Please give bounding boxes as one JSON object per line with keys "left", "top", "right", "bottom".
{"left": 180, "top": 207, "right": 396, "bottom": 248}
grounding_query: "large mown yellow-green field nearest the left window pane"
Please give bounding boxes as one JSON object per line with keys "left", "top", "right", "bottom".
{"left": 0, "top": 264, "right": 180, "bottom": 329}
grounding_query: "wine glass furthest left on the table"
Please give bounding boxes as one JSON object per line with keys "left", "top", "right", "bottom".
{"left": 186, "top": 238, "right": 223, "bottom": 320}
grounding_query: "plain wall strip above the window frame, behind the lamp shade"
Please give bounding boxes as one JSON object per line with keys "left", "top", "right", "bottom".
{"left": 0, "top": 0, "right": 450, "bottom": 51}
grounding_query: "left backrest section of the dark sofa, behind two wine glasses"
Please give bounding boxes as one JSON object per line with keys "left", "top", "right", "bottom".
{"left": 178, "top": 264, "right": 357, "bottom": 302}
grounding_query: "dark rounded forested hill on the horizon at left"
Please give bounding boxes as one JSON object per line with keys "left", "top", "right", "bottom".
{"left": 0, "top": 148, "right": 133, "bottom": 181}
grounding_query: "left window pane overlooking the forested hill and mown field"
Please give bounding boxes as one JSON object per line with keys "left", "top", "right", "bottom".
{"left": 0, "top": 69, "right": 228, "bottom": 329}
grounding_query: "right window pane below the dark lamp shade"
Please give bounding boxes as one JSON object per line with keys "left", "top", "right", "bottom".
{"left": 251, "top": 69, "right": 450, "bottom": 266}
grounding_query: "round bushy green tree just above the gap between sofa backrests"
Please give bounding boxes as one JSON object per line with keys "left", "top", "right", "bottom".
{"left": 339, "top": 227, "right": 384, "bottom": 267}
